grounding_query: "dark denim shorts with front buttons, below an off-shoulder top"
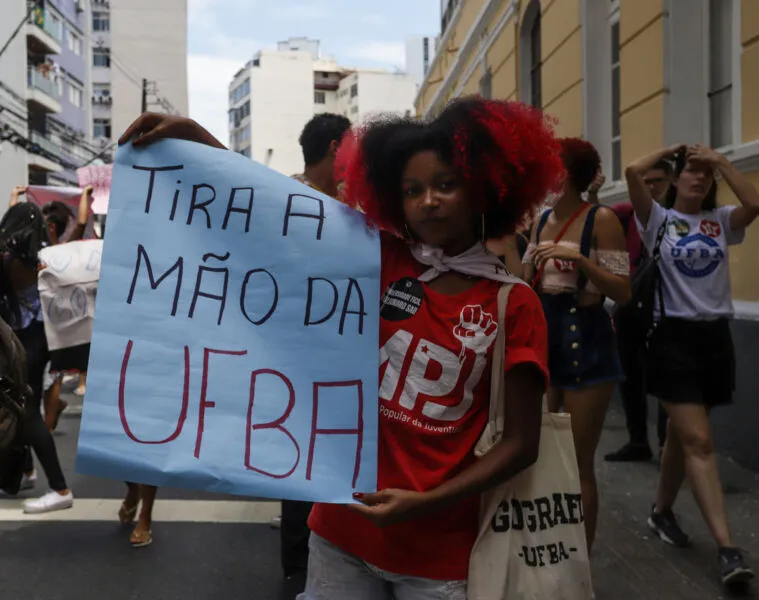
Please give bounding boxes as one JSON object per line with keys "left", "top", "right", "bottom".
{"left": 540, "top": 293, "right": 624, "bottom": 390}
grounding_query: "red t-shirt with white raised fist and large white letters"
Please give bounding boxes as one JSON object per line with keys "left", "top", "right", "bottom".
{"left": 309, "top": 236, "right": 548, "bottom": 580}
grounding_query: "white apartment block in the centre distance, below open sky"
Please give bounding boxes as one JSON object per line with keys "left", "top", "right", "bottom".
{"left": 229, "top": 38, "right": 416, "bottom": 175}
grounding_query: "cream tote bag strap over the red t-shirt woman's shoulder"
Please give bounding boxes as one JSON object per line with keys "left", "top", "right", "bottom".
{"left": 474, "top": 283, "right": 515, "bottom": 457}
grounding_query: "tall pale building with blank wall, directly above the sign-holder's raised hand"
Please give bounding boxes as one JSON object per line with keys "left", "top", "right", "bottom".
{"left": 92, "top": 0, "right": 189, "bottom": 146}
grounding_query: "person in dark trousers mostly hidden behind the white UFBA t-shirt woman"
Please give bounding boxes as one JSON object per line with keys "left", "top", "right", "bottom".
{"left": 604, "top": 160, "right": 672, "bottom": 462}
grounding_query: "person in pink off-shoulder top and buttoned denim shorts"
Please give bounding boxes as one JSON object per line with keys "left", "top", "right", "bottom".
{"left": 524, "top": 138, "right": 630, "bottom": 550}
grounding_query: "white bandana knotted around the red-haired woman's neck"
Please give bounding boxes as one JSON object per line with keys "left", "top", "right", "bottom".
{"left": 411, "top": 243, "right": 522, "bottom": 283}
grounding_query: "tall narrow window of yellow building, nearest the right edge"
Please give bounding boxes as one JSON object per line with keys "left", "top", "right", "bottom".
{"left": 707, "top": 0, "right": 733, "bottom": 148}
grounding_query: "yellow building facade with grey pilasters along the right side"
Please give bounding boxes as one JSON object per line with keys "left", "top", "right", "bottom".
{"left": 416, "top": 0, "right": 759, "bottom": 320}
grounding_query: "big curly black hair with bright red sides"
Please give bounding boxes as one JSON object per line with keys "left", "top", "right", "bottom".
{"left": 335, "top": 97, "right": 564, "bottom": 239}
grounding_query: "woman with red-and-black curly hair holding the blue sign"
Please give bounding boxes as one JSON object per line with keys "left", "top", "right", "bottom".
{"left": 121, "top": 99, "right": 563, "bottom": 600}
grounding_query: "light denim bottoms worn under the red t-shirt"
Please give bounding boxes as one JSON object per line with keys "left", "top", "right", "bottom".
{"left": 297, "top": 533, "right": 466, "bottom": 600}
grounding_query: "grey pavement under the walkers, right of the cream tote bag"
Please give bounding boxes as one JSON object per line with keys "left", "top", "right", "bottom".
{"left": 591, "top": 404, "right": 759, "bottom": 600}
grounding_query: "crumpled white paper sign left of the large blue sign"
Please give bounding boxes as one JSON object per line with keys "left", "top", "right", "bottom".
{"left": 39, "top": 240, "right": 103, "bottom": 351}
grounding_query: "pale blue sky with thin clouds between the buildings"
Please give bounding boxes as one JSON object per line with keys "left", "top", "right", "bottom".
{"left": 188, "top": 0, "right": 440, "bottom": 142}
